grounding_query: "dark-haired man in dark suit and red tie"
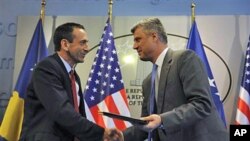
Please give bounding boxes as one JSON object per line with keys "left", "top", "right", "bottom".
{"left": 20, "top": 23, "right": 122, "bottom": 141}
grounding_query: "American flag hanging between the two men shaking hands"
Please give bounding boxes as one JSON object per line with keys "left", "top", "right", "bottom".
{"left": 84, "top": 19, "right": 131, "bottom": 130}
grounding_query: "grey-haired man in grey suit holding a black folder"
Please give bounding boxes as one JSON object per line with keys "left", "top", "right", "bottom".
{"left": 123, "top": 18, "right": 229, "bottom": 141}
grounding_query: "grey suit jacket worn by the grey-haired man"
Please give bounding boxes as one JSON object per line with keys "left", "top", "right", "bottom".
{"left": 124, "top": 49, "right": 229, "bottom": 141}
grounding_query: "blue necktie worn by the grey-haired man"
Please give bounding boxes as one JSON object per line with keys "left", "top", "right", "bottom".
{"left": 148, "top": 64, "right": 157, "bottom": 141}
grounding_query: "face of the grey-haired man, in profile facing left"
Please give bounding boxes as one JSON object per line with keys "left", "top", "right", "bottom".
{"left": 133, "top": 27, "right": 156, "bottom": 61}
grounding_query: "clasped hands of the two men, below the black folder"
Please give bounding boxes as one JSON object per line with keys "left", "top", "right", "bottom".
{"left": 103, "top": 128, "right": 124, "bottom": 141}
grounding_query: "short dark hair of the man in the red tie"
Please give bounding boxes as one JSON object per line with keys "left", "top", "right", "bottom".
{"left": 53, "top": 23, "right": 85, "bottom": 51}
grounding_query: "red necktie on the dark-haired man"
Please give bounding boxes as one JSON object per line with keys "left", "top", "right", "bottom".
{"left": 70, "top": 70, "right": 79, "bottom": 113}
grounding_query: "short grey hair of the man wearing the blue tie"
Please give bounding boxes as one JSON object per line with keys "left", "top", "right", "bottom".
{"left": 131, "top": 18, "right": 168, "bottom": 44}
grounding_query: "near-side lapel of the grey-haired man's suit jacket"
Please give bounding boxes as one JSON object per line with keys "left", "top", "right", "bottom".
{"left": 157, "top": 49, "right": 173, "bottom": 113}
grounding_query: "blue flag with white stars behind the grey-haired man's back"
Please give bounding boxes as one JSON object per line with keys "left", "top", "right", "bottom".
{"left": 187, "top": 21, "right": 226, "bottom": 125}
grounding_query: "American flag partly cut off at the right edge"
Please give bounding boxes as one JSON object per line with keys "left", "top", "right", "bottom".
{"left": 236, "top": 36, "right": 250, "bottom": 125}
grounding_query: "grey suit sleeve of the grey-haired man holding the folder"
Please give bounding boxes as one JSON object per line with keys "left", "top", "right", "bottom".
{"left": 160, "top": 51, "right": 212, "bottom": 131}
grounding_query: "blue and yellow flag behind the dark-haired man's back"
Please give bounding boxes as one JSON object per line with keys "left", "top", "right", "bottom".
{"left": 0, "top": 18, "right": 48, "bottom": 141}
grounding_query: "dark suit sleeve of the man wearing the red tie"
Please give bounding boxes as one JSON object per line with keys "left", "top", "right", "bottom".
{"left": 32, "top": 61, "right": 104, "bottom": 141}
